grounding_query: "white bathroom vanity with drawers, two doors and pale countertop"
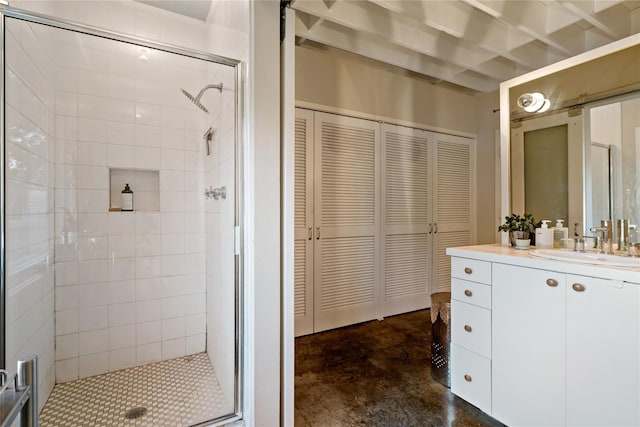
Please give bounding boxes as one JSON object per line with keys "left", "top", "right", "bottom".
{"left": 447, "top": 245, "right": 640, "bottom": 426}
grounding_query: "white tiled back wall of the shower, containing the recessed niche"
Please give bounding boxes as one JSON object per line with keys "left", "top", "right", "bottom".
{"left": 47, "top": 20, "right": 224, "bottom": 381}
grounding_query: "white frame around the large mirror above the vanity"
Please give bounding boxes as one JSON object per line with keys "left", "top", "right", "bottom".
{"left": 496, "top": 33, "right": 640, "bottom": 246}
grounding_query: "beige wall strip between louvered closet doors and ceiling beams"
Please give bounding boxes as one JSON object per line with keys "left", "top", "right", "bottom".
{"left": 296, "top": 45, "right": 477, "bottom": 134}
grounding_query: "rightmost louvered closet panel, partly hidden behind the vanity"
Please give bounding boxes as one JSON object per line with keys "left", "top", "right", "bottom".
{"left": 432, "top": 134, "right": 474, "bottom": 292}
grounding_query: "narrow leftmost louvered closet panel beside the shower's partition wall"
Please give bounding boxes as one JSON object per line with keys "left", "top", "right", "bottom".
{"left": 294, "top": 108, "right": 314, "bottom": 336}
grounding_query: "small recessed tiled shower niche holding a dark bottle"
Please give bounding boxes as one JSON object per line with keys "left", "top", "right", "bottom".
{"left": 109, "top": 169, "right": 160, "bottom": 212}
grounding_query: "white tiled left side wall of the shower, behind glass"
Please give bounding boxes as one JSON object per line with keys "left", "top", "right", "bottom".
{"left": 5, "top": 16, "right": 55, "bottom": 414}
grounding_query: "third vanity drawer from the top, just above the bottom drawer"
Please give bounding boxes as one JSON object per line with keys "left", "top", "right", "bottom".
{"left": 451, "top": 300, "right": 491, "bottom": 358}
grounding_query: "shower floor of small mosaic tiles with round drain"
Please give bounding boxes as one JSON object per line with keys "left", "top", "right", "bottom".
{"left": 40, "top": 353, "right": 226, "bottom": 427}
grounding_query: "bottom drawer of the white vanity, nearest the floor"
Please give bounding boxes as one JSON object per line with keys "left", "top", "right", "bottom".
{"left": 451, "top": 345, "right": 491, "bottom": 415}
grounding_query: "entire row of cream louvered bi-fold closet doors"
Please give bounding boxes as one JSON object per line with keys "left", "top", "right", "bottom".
{"left": 294, "top": 109, "right": 472, "bottom": 336}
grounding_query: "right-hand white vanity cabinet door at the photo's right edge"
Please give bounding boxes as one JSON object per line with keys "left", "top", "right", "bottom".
{"left": 567, "top": 275, "right": 640, "bottom": 426}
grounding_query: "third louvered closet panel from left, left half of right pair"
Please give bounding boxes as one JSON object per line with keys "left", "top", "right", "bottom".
{"left": 382, "top": 124, "right": 432, "bottom": 316}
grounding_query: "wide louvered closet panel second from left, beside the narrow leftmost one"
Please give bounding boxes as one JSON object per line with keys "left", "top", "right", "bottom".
{"left": 314, "top": 113, "right": 380, "bottom": 332}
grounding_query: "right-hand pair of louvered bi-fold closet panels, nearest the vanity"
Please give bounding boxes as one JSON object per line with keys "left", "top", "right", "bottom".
{"left": 381, "top": 124, "right": 473, "bottom": 316}
